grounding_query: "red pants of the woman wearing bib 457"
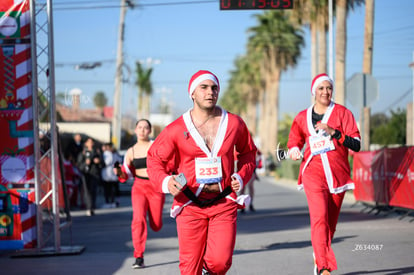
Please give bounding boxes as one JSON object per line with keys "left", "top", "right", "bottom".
{"left": 303, "top": 160, "right": 345, "bottom": 271}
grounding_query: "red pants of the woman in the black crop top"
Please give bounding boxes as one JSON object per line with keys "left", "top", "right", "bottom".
{"left": 131, "top": 178, "right": 165, "bottom": 258}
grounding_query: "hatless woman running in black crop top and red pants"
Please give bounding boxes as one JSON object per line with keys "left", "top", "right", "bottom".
{"left": 114, "top": 119, "right": 165, "bottom": 269}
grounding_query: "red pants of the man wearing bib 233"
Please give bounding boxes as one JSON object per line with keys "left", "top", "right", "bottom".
{"left": 176, "top": 199, "right": 237, "bottom": 275}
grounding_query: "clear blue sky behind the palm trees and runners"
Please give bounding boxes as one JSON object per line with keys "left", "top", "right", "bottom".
{"left": 53, "top": 0, "right": 414, "bottom": 123}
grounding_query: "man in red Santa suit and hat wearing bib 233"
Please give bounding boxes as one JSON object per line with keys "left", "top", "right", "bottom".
{"left": 147, "top": 70, "right": 256, "bottom": 275}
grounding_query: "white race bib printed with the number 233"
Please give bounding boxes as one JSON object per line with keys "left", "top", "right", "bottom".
{"left": 195, "top": 157, "right": 223, "bottom": 184}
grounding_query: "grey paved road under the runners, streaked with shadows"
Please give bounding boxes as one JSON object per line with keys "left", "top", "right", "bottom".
{"left": 0, "top": 177, "right": 414, "bottom": 275}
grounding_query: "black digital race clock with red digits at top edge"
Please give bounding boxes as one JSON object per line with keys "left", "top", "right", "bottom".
{"left": 220, "top": 0, "right": 293, "bottom": 10}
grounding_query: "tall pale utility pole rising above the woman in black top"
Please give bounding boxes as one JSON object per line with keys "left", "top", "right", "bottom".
{"left": 112, "top": 0, "right": 134, "bottom": 150}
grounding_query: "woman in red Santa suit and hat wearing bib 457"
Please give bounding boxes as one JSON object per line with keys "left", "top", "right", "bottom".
{"left": 287, "top": 74, "right": 361, "bottom": 275}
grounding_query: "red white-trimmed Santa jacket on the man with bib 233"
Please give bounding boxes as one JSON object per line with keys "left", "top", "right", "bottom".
{"left": 147, "top": 110, "right": 256, "bottom": 217}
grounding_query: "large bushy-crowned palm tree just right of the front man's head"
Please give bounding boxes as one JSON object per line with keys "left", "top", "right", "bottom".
{"left": 248, "top": 10, "right": 304, "bottom": 160}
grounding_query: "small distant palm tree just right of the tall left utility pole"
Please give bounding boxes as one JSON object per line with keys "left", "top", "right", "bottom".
{"left": 135, "top": 61, "right": 152, "bottom": 119}
